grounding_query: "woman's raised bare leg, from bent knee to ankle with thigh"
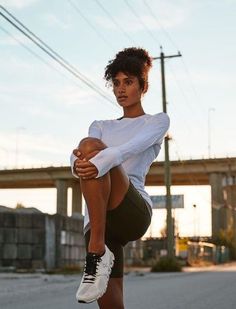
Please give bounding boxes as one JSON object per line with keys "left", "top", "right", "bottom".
{"left": 79, "top": 138, "right": 129, "bottom": 254}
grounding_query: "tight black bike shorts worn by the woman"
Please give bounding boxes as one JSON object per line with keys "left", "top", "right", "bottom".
{"left": 85, "top": 182, "right": 152, "bottom": 278}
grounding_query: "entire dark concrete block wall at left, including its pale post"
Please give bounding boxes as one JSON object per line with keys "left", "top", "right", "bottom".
{"left": 0, "top": 212, "right": 85, "bottom": 269}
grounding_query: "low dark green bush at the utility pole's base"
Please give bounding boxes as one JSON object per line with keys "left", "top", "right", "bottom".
{"left": 151, "top": 256, "right": 182, "bottom": 272}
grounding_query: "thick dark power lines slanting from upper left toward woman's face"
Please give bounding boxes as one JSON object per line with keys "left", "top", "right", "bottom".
{"left": 0, "top": 5, "right": 116, "bottom": 106}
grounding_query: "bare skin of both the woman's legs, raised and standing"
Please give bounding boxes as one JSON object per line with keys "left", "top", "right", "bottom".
{"left": 76, "top": 138, "right": 129, "bottom": 309}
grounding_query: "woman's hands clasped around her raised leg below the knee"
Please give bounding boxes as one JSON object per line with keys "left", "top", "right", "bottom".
{"left": 73, "top": 149, "right": 99, "bottom": 180}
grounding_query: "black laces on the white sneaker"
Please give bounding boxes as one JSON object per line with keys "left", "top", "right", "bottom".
{"left": 83, "top": 253, "right": 101, "bottom": 283}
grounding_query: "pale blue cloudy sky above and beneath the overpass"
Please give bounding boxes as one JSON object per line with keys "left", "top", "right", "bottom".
{"left": 0, "top": 0, "right": 236, "bottom": 234}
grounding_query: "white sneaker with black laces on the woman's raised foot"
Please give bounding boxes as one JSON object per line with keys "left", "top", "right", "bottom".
{"left": 76, "top": 245, "right": 115, "bottom": 303}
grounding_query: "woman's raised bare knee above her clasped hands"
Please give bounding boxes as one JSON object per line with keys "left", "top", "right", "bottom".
{"left": 79, "top": 137, "right": 107, "bottom": 158}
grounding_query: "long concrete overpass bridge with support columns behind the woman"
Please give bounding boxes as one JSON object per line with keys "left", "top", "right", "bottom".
{"left": 0, "top": 157, "right": 236, "bottom": 235}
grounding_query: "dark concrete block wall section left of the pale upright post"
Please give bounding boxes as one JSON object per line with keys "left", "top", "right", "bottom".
{"left": 0, "top": 212, "right": 45, "bottom": 268}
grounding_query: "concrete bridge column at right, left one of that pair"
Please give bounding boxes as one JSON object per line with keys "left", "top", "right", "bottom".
{"left": 209, "top": 173, "right": 227, "bottom": 237}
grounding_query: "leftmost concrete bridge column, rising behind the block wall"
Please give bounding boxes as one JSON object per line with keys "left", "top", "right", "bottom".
{"left": 56, "top": 179, "right": 68, "bottom": 216}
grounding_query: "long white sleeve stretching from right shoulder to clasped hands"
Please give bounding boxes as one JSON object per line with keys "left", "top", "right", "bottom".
{"left": 90, "top": 113, "right": 170, "bottom": 178}
